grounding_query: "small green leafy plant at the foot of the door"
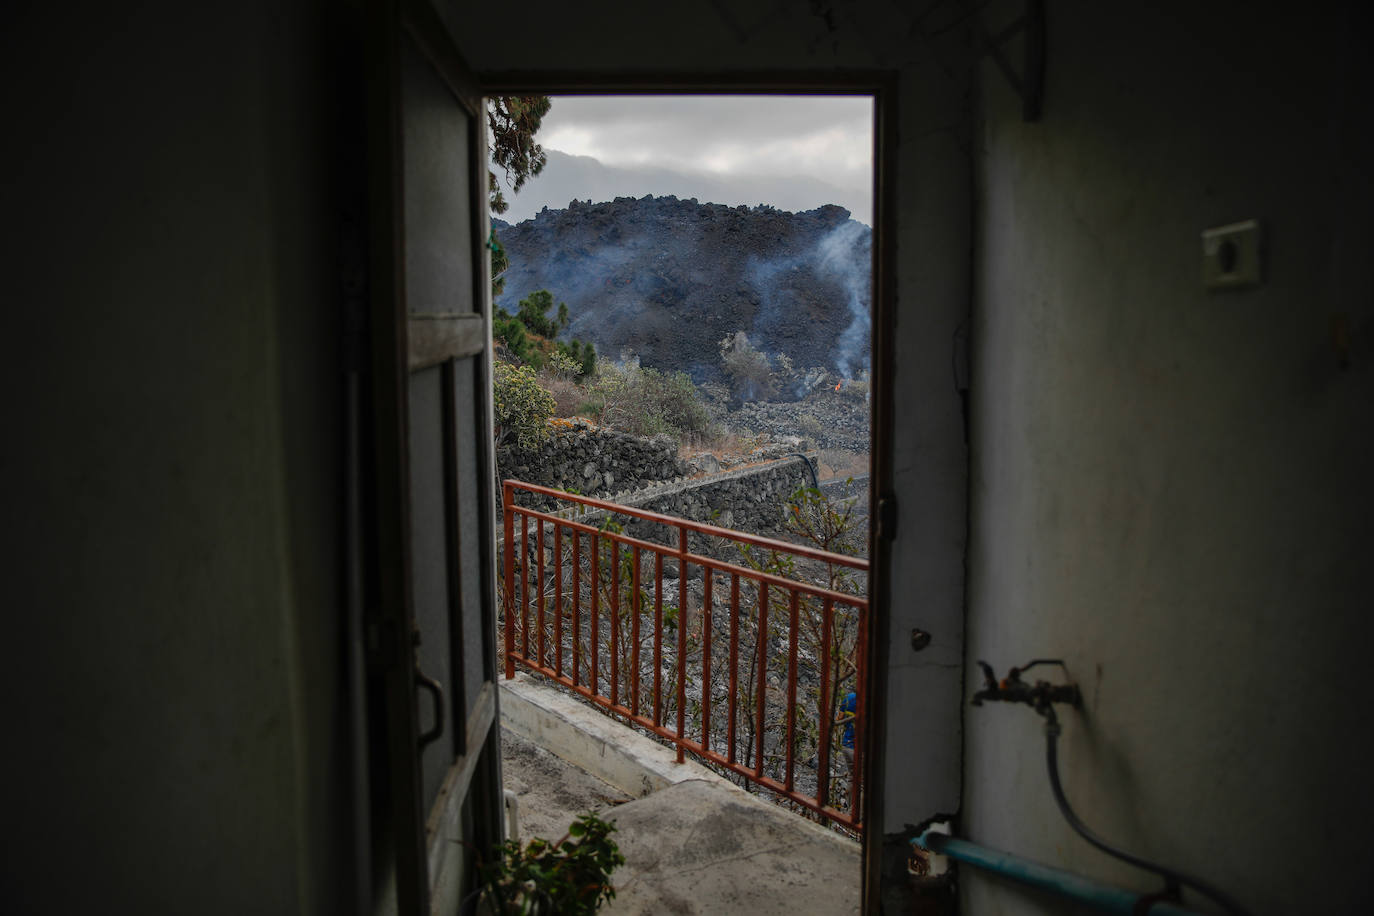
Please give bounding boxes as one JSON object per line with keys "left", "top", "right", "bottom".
{"left": 478, "top": 814, "right": 625, "bottom": 916}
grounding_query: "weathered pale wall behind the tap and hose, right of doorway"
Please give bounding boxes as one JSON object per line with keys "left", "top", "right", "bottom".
{"left": 956, "top": 3, "right": 1374, "bottom": 913}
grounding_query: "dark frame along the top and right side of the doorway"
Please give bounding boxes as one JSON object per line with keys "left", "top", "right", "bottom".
{"left": 477, "top": 70, "right": 900, "bottom": 913}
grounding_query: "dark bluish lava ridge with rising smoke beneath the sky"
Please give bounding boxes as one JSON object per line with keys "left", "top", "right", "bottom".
{"left": 492, "top": 196, "right": 872, "bottom": 382}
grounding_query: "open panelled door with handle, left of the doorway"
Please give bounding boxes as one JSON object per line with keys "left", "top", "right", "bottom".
{"left": 364, "top": 0, "right": 502, "bottom": 913}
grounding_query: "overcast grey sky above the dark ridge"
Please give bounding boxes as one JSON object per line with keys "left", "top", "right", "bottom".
{"left": 496, "top": 96, "right": 872, "bottom": 224}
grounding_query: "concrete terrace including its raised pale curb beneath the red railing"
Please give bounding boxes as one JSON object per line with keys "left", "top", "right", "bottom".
{"left": 502, "top": 674, "right": 860, "bottom": 916}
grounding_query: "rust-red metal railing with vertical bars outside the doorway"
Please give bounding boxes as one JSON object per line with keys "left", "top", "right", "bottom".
{"left": 502, "top": 481, "right": 868, "bottom": 832}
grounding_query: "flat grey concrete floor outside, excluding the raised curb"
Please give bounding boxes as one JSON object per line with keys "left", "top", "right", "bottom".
{"left": 502, "top": 728, "right": 859, "bottom": 916}
